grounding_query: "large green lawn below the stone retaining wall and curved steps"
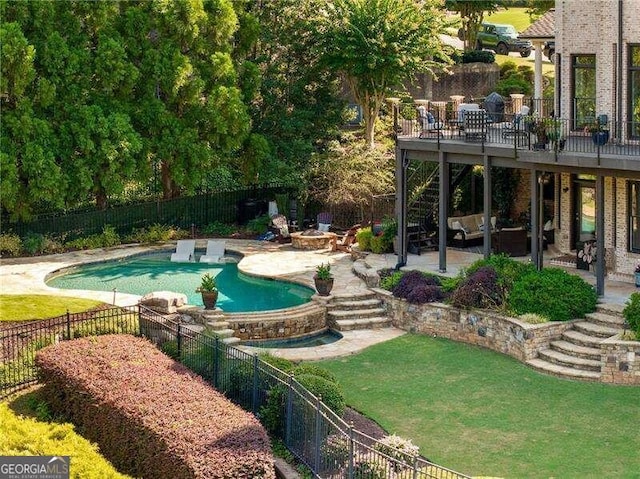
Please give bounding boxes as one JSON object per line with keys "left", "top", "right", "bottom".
{"left": 319, "top": 334, "right": 640, "bottom": 478}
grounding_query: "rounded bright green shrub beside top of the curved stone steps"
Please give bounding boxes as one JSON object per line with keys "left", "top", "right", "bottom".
{"left": 508, "top": 268, "right": 598, "bottom": 321}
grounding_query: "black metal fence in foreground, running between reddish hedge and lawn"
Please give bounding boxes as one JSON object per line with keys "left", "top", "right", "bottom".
{"left": 0, "top": 306, "right": 468, "bottom": 479}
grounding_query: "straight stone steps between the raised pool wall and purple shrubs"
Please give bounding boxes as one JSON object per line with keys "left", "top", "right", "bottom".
{"left": 327, "top": 293, "right": 391, "bottom": 331}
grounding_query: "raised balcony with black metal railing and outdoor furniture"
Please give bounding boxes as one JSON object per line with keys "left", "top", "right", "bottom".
{"left": 396, "top": 101, "right": 640, "bottom": 174}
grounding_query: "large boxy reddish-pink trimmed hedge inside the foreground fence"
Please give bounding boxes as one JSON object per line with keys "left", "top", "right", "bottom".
{"left": 36, "top": 335, "right": 275, "bottom": 479}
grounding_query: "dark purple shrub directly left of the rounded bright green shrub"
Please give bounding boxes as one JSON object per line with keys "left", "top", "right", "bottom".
{"left": 450, "top": 266, "right": 502, "bottom": 309}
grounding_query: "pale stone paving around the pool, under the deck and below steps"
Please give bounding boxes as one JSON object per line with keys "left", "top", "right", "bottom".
{"left": 0, "top": 239, "right": 637, "bottom": 360}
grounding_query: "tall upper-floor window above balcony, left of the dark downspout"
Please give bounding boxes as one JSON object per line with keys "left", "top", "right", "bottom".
{"left": 571, "top": 55, "right": 596, "bottom": 130}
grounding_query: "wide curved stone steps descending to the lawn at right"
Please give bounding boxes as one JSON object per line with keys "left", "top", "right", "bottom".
{"left": 527, "top": 304, "right": 624, "bottom": 381}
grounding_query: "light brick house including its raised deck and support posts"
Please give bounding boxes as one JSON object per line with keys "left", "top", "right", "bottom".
{"left": 396, "top": 0, "right": 640, "bottom": 294}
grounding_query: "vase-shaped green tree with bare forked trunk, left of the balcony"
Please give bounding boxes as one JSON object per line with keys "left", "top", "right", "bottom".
{"left": 315, "top": 0, "right": 450, "bottom": 148}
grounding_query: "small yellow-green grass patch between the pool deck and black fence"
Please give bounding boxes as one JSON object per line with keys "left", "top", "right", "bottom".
{"left": 0, "top": 294, "right": 102, "bottom": 322}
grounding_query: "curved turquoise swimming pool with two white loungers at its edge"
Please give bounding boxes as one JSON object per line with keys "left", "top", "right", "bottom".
{"left": 46, "top": 253, "right": 314, "bottom": 313}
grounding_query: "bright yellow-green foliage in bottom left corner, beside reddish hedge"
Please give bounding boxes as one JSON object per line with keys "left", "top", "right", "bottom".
{"left": 0, "top": 399, "right": 129, "bottom": 479}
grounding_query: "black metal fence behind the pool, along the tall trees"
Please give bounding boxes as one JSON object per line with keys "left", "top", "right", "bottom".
{"left": 2, "top": 184, "right": 293, "bottom": 238}
